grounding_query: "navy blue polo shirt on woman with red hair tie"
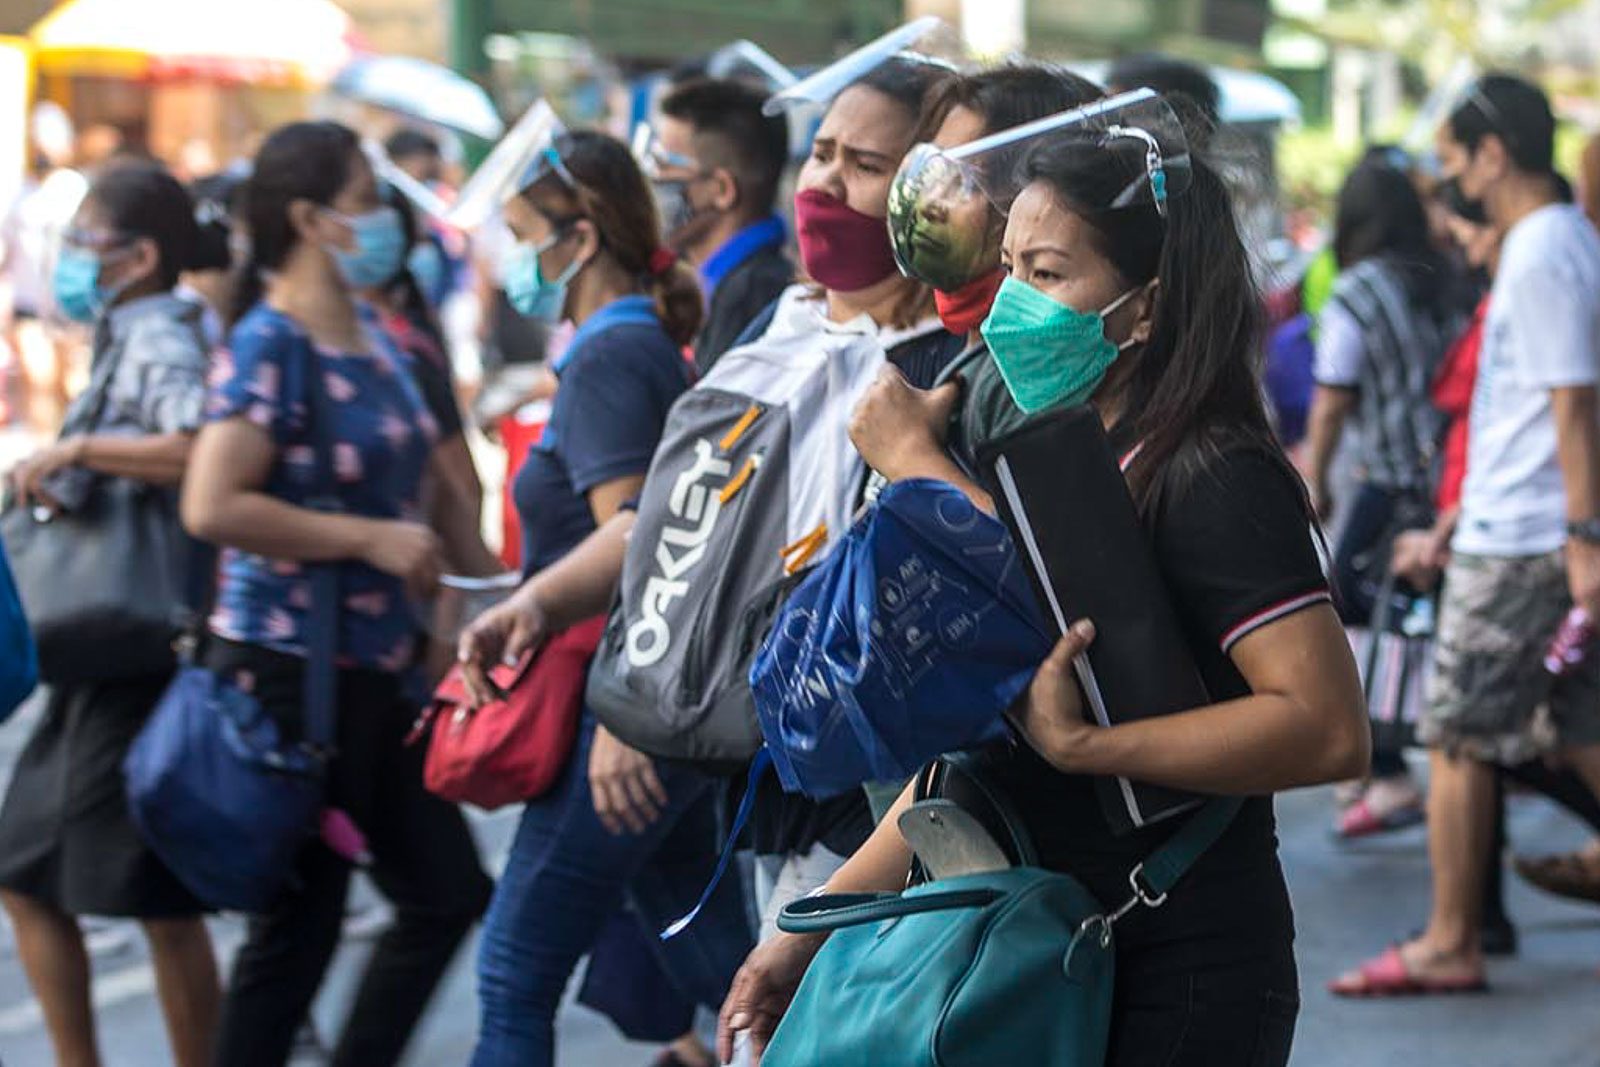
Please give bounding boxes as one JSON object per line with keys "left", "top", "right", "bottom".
{"left": 512, "top": 296, "right": 691, "bottom": 574}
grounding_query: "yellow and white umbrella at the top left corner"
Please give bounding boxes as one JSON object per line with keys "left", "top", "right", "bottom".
{"left": 29, "top": 0, "right": 360, "bottom": 85}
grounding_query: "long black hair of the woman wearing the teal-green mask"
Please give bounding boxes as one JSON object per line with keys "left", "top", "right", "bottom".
{"left": 1024, "top": 127, "right": 1310, "bottom": 518}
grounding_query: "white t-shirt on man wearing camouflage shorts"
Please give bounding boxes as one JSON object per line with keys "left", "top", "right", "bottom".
{"left": 1454, "top": 205, "right": 1600, "bottom": 557}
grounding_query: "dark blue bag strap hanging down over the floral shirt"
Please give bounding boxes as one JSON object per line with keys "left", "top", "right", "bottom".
{"left": 299, "top": 338, "right": 342, "bottom": 755}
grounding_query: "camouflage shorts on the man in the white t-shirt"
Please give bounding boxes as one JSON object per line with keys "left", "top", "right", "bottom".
{"left": 1418, "top": 552, "right": 1600, "bottom": 763}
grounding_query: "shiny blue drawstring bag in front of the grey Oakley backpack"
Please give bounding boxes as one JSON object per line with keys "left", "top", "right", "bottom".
{"left": 750, "top": 478, "right": 1053, "bottom": 798}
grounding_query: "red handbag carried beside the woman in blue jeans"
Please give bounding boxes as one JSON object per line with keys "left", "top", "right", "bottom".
{"left": 408, "top": 616, "right": 605, "bottom": 809}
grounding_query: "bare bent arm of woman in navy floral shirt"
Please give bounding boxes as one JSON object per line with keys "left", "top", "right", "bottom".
{"left": 181, "top": 418, "right": 440, "bottom": 592}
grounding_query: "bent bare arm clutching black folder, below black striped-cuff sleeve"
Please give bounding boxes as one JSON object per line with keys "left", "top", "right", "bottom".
{"left": 1016, "top": 605, "right": 1371, "bottom": 797}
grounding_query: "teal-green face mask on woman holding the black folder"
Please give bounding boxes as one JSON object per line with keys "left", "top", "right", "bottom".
{"left": 979, "top": 277, "right": 1144, "bottom": 414}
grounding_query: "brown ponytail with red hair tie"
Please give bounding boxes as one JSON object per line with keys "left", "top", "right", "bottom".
{"left": 522, "top": 130, "right": 706, "bottom": 344}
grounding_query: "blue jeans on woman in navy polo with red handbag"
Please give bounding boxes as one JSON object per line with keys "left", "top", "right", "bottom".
{"left": 472, "top": 713, "right": 752, "bottom": 1067}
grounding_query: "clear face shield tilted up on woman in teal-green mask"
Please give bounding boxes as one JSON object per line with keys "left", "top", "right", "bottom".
{"left": 888, "top": 90, "right": 1192, "bottom": 293}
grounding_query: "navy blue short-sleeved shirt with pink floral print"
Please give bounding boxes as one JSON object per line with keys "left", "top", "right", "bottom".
{"left": 206, "top": 304, "right": 438, "bottom": 673}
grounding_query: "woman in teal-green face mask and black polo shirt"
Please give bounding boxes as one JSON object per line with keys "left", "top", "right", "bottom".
{"left": 723, "top": 102, "right": 1368, "bottom": 1067}
